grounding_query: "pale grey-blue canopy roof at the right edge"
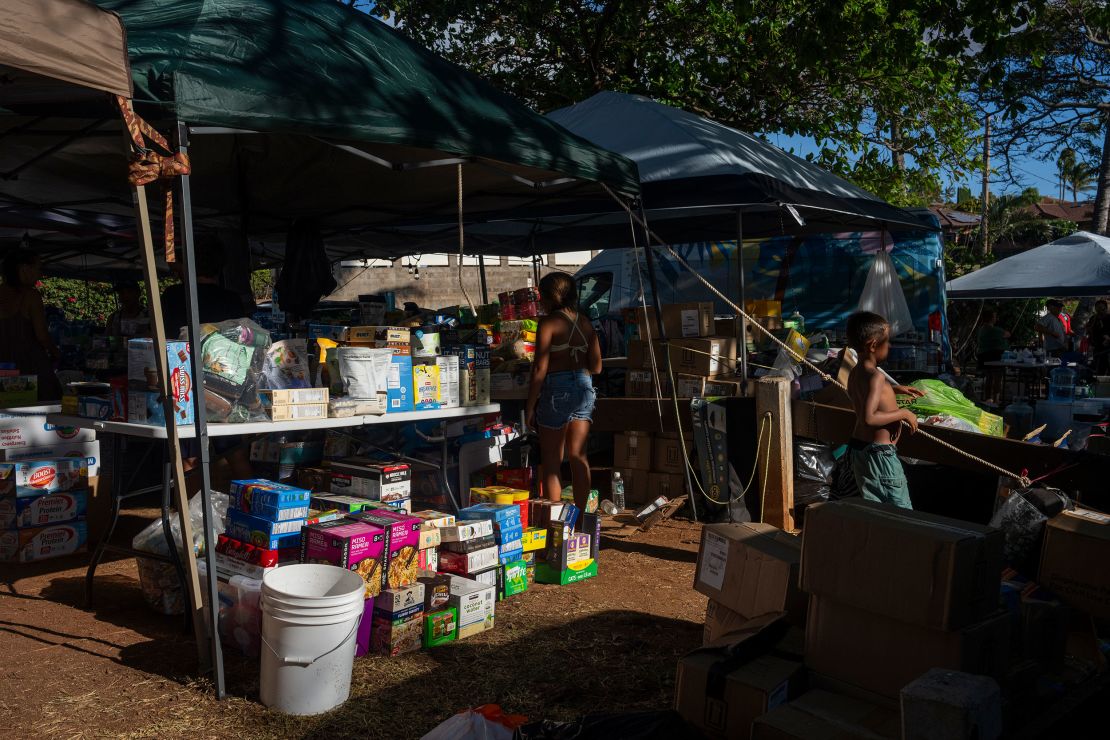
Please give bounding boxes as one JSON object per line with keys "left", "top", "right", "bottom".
{"left": 948, "top": 231, "right": 1110, "bottom": 298}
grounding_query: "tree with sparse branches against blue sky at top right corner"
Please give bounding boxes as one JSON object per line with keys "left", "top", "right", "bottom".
{"left": 979, "top": 0, "right": 1110, "bottom": 234}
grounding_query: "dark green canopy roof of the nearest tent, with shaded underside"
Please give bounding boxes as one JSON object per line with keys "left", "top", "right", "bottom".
{"left": 0, "top": 0, "right": 638, "bottom": 274}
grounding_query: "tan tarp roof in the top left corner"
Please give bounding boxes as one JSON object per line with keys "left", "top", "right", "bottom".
{"left": 0, "top": 0, "right": 131, "bottom": 105}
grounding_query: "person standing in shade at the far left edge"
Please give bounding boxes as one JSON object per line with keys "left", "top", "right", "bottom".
{"left": 0, "top": 247, "right": 62, "bottom": 402}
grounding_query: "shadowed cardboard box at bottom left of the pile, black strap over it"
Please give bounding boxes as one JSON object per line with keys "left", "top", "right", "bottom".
{"left": 675, "top": 648, "right": 804, "bottom": 739}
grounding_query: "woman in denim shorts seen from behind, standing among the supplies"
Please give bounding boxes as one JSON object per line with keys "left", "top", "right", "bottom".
{"left": 527, "top": 272, "right": 602, "bottom": 510}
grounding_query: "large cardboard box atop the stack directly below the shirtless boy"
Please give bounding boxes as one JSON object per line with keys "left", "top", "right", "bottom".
{"left": 800, "top": 501, "right": 1002, "bottom": 630}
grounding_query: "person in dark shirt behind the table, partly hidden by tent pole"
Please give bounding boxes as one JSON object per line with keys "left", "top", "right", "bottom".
{"left": 162, "top": 235, "right": 254, "bottom": 339}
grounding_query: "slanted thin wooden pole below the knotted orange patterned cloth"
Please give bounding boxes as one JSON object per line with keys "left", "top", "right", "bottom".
{"left": 132, "top": 186, "right": 211, "bottom": 671}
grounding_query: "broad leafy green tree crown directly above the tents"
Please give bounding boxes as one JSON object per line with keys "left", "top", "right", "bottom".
{"left": 373, "top": 0, "right": 1028, "bottom": 204}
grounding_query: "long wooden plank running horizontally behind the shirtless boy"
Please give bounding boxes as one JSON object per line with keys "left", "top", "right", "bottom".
{"left": 793, "top": 401, "right": 1110, "bottom": 508}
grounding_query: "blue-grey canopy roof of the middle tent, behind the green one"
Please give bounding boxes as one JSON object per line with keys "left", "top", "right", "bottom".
{"left": 352, "top": 92, "right": 937, "bottom": 254}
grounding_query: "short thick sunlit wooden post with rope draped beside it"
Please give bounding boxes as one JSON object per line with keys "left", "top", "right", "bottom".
{"left": 756, "top": 377, "right": 794, "bottom": 531}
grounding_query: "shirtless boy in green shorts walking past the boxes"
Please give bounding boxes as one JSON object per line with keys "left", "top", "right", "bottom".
{"left": 848, "top": 312, "right": 924, "bottom": 509}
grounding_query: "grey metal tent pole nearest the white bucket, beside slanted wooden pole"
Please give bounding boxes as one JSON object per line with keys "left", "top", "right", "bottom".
{"left": 176, "top": 121, "right": 226, "bottom": 699}
